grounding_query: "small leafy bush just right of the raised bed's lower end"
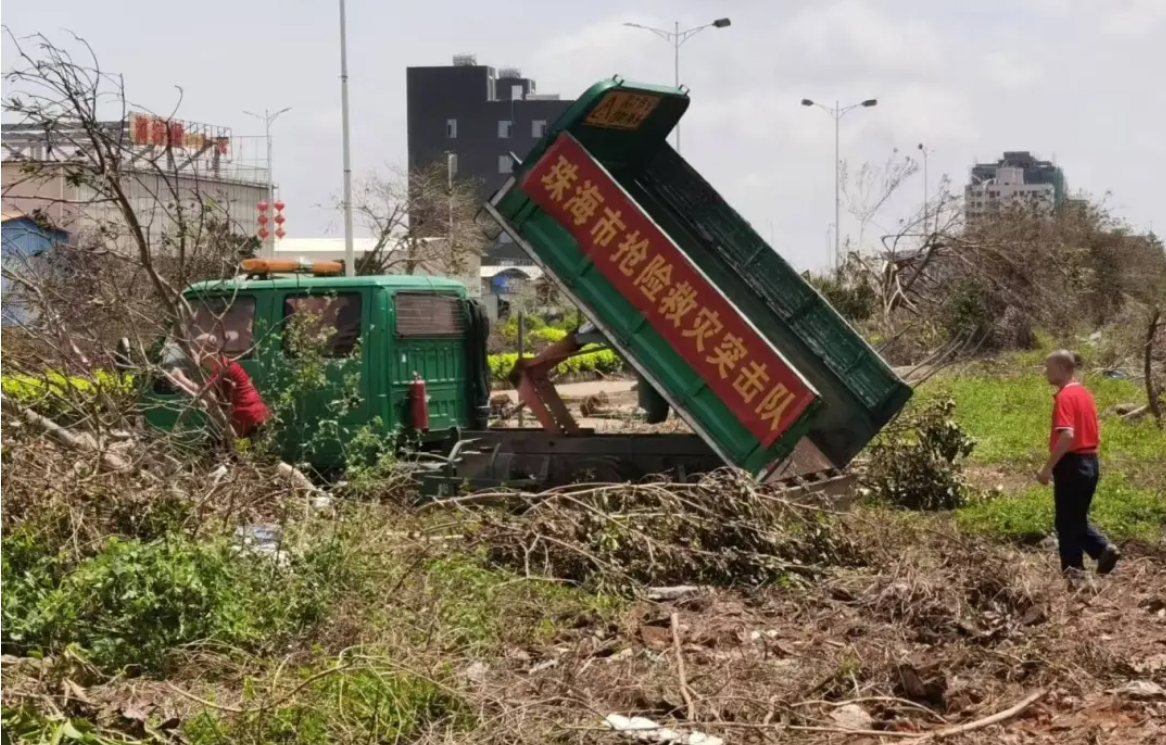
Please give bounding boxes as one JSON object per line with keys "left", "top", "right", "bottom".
{"left": 868, "top": 399, "right": 976, "bottom": 509}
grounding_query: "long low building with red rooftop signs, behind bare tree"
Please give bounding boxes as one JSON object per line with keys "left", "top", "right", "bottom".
{"left": 2, "top": 114, "right": 269, "bottom": 251}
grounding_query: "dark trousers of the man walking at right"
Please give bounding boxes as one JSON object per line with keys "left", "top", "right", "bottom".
{"left": 1053, "top": 452, "right": 1109, "bottom": 571}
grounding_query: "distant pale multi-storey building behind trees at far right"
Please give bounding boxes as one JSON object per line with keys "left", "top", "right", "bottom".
{"left": 964, "top": 152, "right": 1066, "bottom": 223}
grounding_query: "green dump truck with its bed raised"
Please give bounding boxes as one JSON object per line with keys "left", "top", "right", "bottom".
{"left": 148, "top": 77, "right": 911, "bottom": 489}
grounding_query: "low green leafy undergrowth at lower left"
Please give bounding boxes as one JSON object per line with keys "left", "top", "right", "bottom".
{"left": 2, "top": 530, "right": 361, "bottom": 670}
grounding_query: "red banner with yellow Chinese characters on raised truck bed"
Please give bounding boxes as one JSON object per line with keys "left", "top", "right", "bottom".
{"left": 522, "top": 133, "right": 815, "bottom": 447}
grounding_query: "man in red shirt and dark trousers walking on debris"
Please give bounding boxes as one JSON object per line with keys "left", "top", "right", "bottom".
{"left": 1037, "top": 350, "right": 1122, "bottom": 575}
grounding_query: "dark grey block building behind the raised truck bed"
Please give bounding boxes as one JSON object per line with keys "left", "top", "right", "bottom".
{"left": 406, "top": 55, "right": 574, "bottom": 263}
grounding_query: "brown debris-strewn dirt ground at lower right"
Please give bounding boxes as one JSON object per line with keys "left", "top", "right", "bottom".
{"left": 473, "top": 524, "right": 1166, "bottom": 745}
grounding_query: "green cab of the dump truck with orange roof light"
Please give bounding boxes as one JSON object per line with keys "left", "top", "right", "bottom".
{"left": 145, "top": 268, "right": 490, "bottom": 471}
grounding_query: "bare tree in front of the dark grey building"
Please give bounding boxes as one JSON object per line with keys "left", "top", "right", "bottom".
{"left": 353, "top": 162, "right": 487, "bottom": 276}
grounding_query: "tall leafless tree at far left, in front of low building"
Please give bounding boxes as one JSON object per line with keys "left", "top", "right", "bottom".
{"left": 2, "top": 28, "right": 257, "bottom": 443}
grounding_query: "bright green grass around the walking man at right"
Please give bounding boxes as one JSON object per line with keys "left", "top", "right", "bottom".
{"left": 920, "top": 368, "right": 1166, "bottom": 543}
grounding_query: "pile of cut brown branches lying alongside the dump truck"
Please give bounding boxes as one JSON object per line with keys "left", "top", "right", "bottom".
{"left": 473, "top": 471, "right": 863, "bottom": 591}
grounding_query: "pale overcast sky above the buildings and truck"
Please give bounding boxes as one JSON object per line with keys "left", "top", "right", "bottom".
{"left": 2, "top": 0, "right": 1166, "bottom": 268}
